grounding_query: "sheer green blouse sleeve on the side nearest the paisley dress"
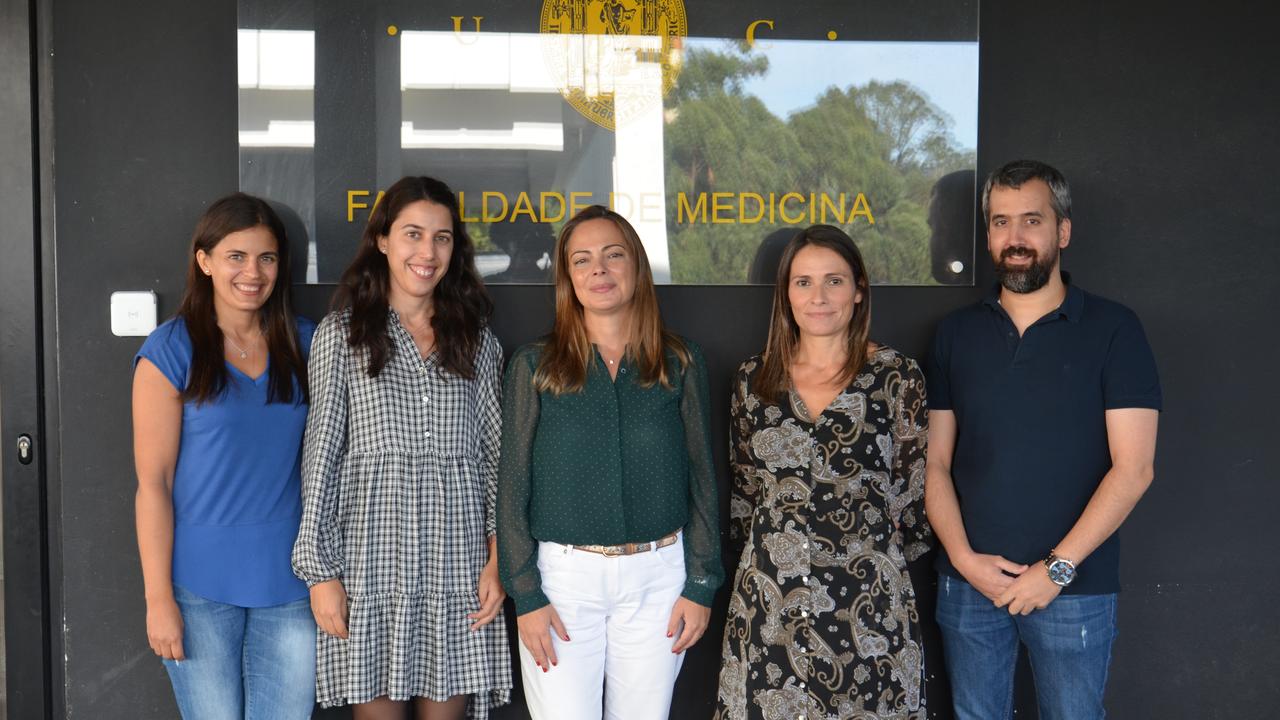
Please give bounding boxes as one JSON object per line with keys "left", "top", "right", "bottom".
{"left": 680, "top": 343, "right": 724, "bottom": 607}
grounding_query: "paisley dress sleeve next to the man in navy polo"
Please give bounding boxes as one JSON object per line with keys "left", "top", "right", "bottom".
{"left": 890, "top": 359, "right": 933, "bottom": 560}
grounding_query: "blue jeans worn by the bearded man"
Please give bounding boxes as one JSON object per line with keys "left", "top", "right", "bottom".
{"left": 937, "top": 575, "right": 1116, "bottom": 720}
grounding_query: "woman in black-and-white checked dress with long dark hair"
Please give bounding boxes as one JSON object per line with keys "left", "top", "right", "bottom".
{"left": 293, "top": 177, "right": 511, "bottom": 720}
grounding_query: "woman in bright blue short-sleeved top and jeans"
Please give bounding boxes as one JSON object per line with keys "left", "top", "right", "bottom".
{"left": 133, "top": 193, "right": 315, "bottom": 720}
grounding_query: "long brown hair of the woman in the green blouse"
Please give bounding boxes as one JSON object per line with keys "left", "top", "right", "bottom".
{"left": 534, "top": 205, "right": 690, "bottom": 395}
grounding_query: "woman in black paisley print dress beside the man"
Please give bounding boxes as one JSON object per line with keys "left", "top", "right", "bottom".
{"left": 716, "top": 225, "right": 932, "bottom": 720}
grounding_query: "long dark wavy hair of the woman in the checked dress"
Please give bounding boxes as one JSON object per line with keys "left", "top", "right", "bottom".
{"left": 333, "top": 176, "right": 493, "bottom": 379}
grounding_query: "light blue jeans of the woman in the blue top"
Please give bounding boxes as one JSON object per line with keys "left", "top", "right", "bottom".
{"left": 164, "top": 585, "right": 316, "bottom": 720}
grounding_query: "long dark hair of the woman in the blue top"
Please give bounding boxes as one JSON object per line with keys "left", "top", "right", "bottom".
{"left": 178, "top": 192, "right": 310, "bottom": 404}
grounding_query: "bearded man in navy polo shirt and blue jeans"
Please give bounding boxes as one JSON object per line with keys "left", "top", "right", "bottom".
{"left": 925, "top": 160, "right": 1161, "bottom": 720}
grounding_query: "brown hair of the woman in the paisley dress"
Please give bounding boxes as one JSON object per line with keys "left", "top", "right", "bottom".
{"left": 753, "top": 225, "right": 872, "bottom": 404}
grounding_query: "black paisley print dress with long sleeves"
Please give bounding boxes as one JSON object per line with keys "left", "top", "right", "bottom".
{"left": 716, "top": 346, "right": 932, "bottom": 720}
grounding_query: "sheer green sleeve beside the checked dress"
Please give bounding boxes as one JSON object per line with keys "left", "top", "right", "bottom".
{"left": 497, "top": 345, "right": 550, "bottom": 615}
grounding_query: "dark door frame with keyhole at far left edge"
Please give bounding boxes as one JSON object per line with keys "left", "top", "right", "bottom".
{"left": 0, "top": 0, "right": 61, "bottom": 719}
